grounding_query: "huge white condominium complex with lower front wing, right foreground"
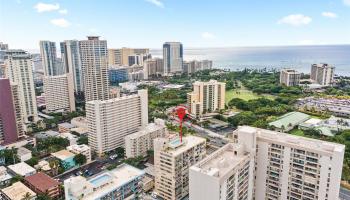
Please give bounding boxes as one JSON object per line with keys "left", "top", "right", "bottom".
{"left": 190, "top": 126, "right": 345, "bottom": 200}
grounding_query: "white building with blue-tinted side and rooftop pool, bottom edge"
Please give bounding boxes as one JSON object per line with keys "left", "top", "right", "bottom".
{"left": 64, "top": 164, "right": 144, "bottom": 200}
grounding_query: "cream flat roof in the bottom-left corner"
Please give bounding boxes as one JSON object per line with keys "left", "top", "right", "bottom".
{"left": 2, "top": 182, "right": 36, "bottom": 200}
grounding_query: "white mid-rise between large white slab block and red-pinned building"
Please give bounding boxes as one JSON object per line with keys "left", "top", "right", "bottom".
{"left": 125, "top": 119, "right": 166, "bottom": 158}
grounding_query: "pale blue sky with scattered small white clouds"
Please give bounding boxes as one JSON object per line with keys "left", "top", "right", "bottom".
{"left": 0, "top": 0, "right": 350, "bottom": 49}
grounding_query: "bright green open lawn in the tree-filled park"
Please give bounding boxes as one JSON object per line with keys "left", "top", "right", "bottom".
{"left": 225, "top": 89, "right": 275, "bottom": 103}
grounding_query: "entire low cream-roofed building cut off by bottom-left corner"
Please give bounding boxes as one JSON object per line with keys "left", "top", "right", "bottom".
{"left": 1, "top": 182, "right": 36, "bottom": 200}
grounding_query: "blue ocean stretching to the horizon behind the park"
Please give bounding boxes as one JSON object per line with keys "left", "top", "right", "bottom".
{"left": 151, "top": 45, "right": 350, "bottom": 76}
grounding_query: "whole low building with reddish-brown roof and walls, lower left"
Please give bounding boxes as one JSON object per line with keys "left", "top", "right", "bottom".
{"left": 24, "top": 172, "right": 61, "bottom": 198}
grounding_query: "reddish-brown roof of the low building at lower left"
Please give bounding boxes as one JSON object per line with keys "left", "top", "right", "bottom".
{"left": 25, "top": 172, "right": 60, "bottom": 193}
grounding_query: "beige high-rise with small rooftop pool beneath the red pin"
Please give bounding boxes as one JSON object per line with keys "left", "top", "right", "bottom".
{"left": 154, "top": 136, "right": 206, "bottom": 200}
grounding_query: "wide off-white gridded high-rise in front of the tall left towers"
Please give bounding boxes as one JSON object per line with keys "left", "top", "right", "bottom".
{"left": 43, "top": 73, "right": 75, "bottom": 112}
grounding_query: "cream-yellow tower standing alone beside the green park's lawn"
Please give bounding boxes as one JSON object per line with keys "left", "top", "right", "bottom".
{"left": 187, "top": 80, "right": 226, "bottom": 117}
